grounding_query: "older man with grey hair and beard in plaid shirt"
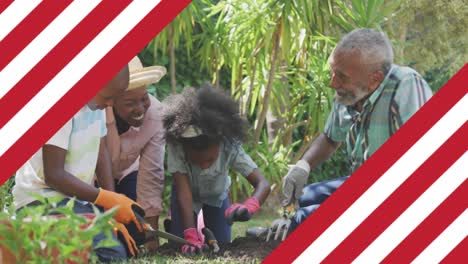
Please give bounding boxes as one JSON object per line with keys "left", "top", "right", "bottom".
{"left": 283, "top": 29, "right": 432, "bottom": 230}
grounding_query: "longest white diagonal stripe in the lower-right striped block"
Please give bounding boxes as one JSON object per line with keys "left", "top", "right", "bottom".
{"left": 295, "top": 95, "right": 468, "bottom": 263}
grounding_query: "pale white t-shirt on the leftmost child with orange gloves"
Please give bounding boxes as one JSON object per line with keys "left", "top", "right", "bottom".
{"left": 13, "top": 106, "right": 107, "bottom": 208}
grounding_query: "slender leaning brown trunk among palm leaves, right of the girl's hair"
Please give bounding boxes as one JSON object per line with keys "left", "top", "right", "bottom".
{"left": 254, "top": 18, "right": 281, "bottom": 144}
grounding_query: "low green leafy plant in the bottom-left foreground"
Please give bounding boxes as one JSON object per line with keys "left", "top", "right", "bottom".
{"left": 0, "top": 197, "right": 115, "bottom": 263}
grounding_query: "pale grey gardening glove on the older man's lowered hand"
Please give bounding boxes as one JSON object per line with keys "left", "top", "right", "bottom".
{"left": 282, "top": 160, "right": 310, "bottom": 206}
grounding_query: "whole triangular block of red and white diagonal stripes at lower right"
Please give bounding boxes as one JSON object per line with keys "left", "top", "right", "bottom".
{"left": 264, "top": 65, "right": 468, "bottom": 263}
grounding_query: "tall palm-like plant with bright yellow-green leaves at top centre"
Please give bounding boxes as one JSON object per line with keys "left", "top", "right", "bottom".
{"left": 203, "top": 0, "right": 332, "bottom": 145}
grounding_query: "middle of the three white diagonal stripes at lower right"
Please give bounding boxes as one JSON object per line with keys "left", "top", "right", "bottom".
{"left": 353, "top": 152, "right": 468, "bottom": 264}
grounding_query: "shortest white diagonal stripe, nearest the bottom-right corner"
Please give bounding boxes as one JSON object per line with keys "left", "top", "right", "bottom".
{"left": 412, "top": 209, "right": 468, "bottom": 264}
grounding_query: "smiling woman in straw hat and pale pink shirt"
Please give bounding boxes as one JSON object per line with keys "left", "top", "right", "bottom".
{"left": 106, "top": 57, "right": 166, "bottom": 251}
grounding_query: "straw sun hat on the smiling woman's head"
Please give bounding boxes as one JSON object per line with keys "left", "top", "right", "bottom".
{"left": 127, "top": 56, "right": 167, "bottom": 91}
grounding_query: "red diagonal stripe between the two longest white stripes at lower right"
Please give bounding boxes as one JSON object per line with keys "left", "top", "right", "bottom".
{"left": 323, "top": 123, "right": 468, "bottom": 263}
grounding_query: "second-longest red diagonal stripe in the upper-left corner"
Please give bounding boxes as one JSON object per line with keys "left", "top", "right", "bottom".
{"left": 0, "top": 0, "right": 131, "bottom": 128}
